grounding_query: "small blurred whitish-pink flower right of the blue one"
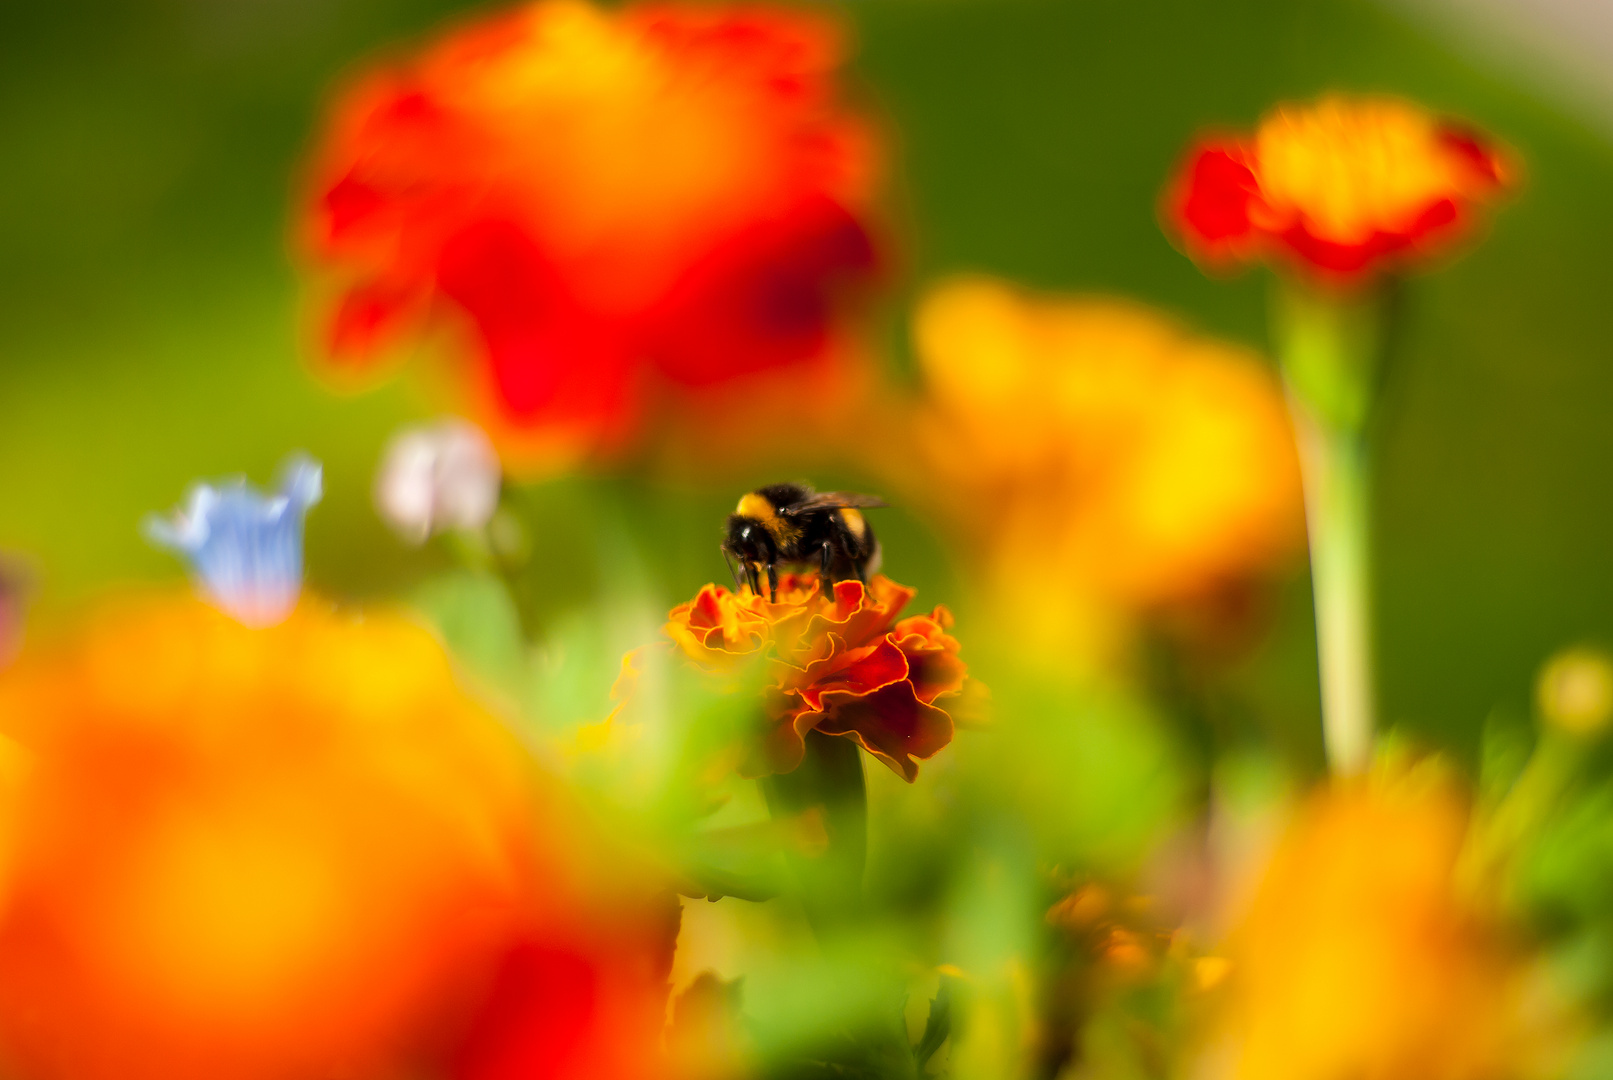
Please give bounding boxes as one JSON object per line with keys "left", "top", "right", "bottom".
{"left": 376, "top": 419, "right": 502, "bottom": 543}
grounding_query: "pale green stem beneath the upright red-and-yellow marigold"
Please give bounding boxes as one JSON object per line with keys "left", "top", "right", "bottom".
{"left": 1273, "top": 275, "right": 1381, "bottom": 775}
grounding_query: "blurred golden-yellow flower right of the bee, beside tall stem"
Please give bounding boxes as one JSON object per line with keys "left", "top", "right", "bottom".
{"left": 894, "top": 277, "right": 1303, "bottom": 653}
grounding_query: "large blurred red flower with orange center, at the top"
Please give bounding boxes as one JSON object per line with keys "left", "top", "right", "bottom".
{"left": 302, "top": 0, "right": 874, "bottom": 461}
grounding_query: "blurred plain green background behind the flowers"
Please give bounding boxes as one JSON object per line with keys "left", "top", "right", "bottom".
{"left": 0, "top": 0, "right": 1613, "bottom": 760}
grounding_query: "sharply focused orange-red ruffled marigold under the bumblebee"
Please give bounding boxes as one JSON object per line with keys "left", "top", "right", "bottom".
{"left": 666, "top": 574, "right": 966, "bottom": 782}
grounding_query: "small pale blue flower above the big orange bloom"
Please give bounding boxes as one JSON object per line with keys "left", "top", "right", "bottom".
{"left": 145, "top": 455, "right": 323, "bottom": 627}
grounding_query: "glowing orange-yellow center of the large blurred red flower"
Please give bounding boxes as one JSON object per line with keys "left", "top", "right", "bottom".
{"left": 464, "top": 0, "right": 819, "bottom": 306}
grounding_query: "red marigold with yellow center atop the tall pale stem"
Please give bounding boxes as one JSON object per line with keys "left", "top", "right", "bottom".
{"left": 1166, "top": 97, "right": 1511, "bottom": 280}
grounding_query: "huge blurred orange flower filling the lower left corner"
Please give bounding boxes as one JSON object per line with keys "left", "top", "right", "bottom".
{"left": 0, "top": 598, "right": 671, "bottom": 1080}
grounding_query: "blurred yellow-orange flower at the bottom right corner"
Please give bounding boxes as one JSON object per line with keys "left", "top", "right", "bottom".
{"left": 1203, "top": 771, "right": 1547, "bottom": 1080}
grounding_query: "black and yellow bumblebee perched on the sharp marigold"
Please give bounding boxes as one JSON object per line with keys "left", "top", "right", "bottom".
{"left": 723, "top": 484, "right": 886, "bottom": 600}
